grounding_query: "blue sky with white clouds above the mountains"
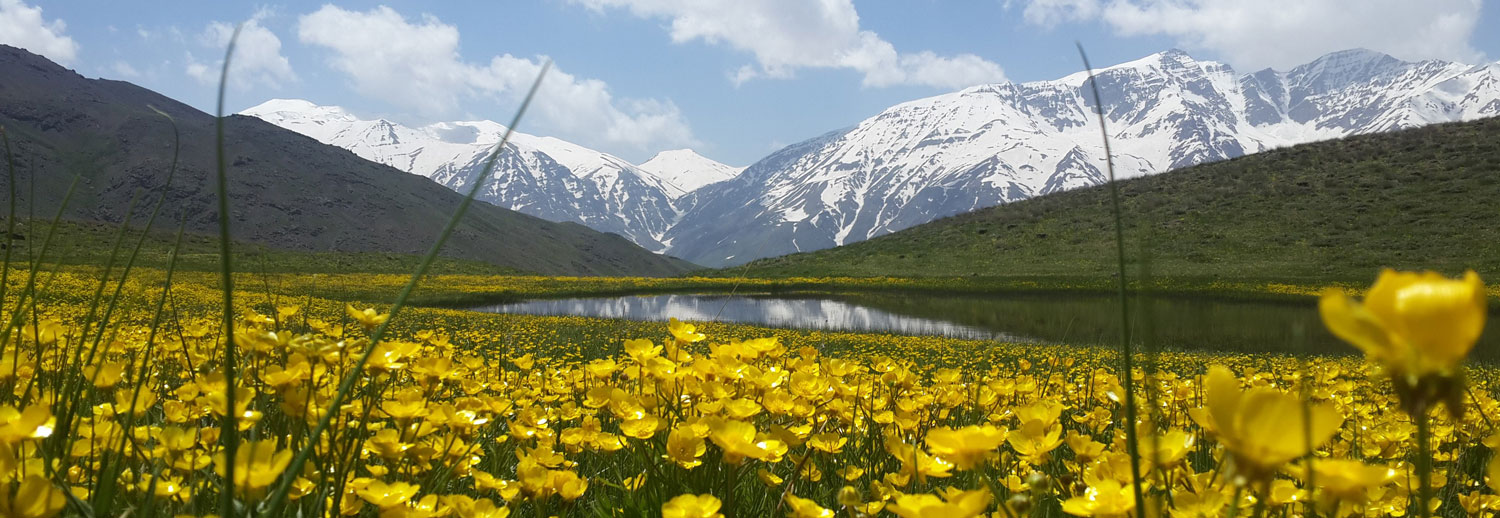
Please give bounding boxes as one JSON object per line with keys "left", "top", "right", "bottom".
{"left": 0, "top": 0, "right": 1500, "bottom": 165}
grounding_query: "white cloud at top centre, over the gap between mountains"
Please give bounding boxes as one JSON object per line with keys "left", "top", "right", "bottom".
{"left": 573, "top": 0, "right": 1005, "bottom": 89}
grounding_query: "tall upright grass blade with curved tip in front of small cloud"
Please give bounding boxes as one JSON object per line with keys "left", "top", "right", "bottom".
{"left": 213, "top": 24, "right": 245, "bottom": 518}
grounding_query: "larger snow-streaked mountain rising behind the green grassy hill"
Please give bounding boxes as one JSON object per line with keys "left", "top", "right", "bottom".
{"left": 665, "top": 50, "right": 1500, "bottom": 266}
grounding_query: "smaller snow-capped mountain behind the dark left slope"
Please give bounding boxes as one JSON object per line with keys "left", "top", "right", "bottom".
{"left": 242, "top": 99, "right": 732, "bottom": 251}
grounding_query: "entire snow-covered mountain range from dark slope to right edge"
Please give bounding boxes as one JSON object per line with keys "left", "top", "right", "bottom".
{"left": 245, "top": 50, "right": 1500, "bottom": 266}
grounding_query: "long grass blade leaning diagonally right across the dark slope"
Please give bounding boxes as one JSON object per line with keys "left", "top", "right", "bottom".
{"left": 261, "top": 62, "right": 552, "bottom": 515}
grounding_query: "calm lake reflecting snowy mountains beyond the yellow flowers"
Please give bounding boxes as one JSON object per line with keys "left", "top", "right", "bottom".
{"left": 473, "top": 294, "right": 1500, "bottom": 360}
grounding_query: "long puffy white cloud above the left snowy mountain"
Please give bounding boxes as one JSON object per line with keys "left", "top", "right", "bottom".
{"left": 297, "top": 6, "right": 698, "bottom": 150}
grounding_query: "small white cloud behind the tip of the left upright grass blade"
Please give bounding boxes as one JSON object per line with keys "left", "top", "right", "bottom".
{"left": 188, "top": 14, "right": 297, "bottom": 90}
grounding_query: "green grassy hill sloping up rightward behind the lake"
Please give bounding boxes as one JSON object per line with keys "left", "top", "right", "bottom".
{"left": 719, "top": 119, "right": 1500, "bottom": 281}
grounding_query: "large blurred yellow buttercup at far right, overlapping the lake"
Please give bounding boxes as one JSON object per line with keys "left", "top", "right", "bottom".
{"left": 1319, "top": 270, "right": 1487, "bottom": 377}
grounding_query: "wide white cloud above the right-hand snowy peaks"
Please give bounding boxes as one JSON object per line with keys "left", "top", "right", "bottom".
{"left": 1013, "top": 0, "right": 1482, "bottom": 71}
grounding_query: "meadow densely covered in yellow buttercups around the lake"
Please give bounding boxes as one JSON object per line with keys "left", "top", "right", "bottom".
{"left": 0, "top": 266, "right": 1500, "bottom": 516}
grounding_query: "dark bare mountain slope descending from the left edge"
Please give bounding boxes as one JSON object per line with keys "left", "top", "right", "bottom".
{"left": 0, "top": 45, "right": 689, "bottom": 275}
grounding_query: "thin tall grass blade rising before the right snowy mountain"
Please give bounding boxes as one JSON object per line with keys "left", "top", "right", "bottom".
{"left": 1077, "top": 44, "right": 1146, "bottom": 518}
